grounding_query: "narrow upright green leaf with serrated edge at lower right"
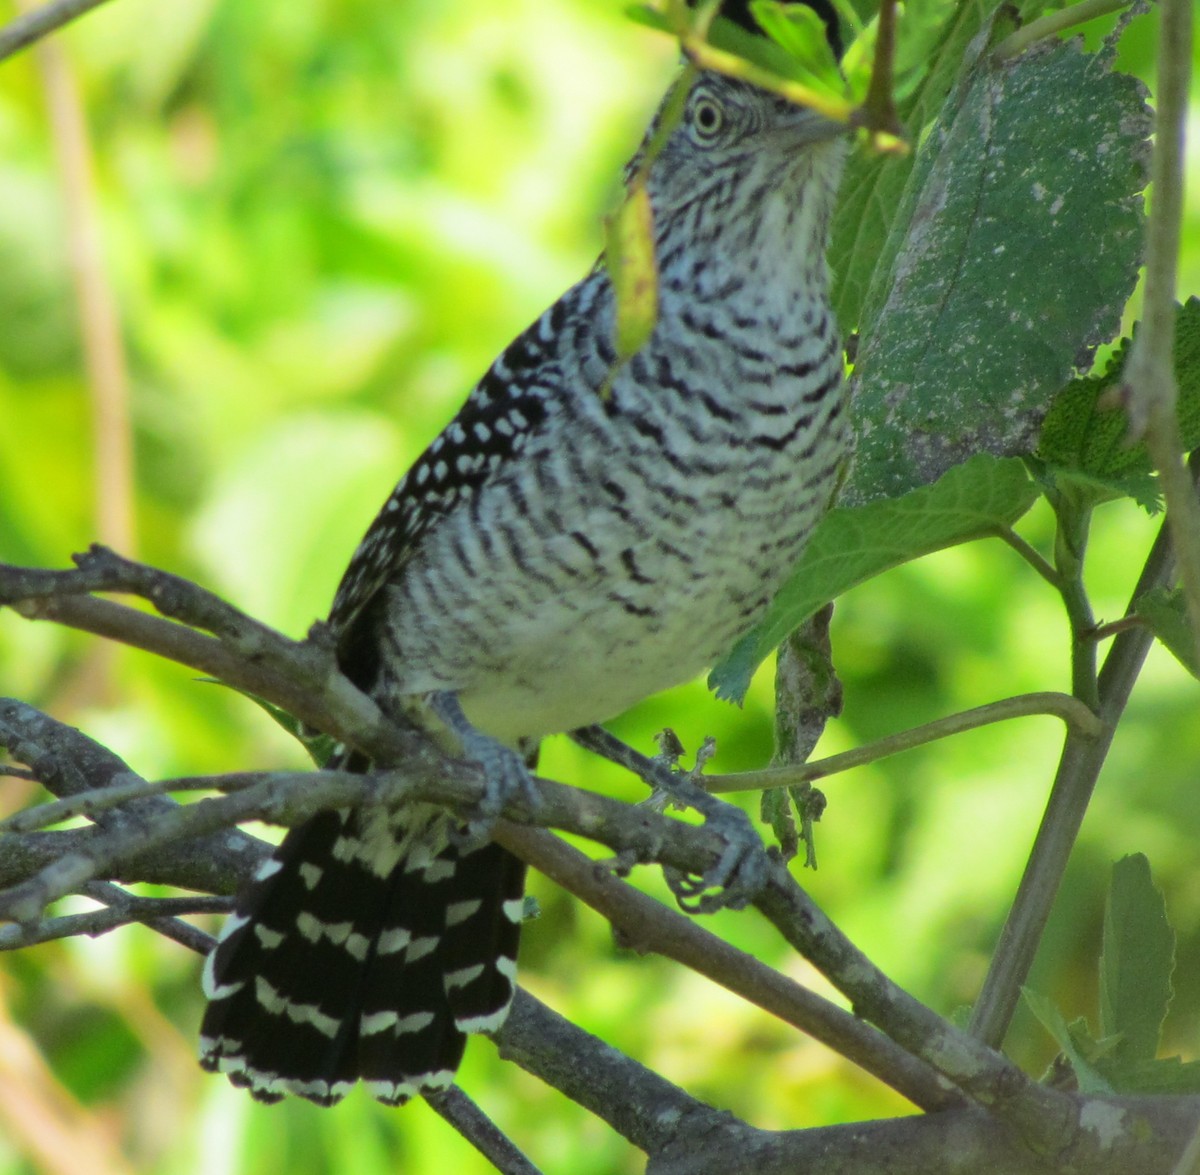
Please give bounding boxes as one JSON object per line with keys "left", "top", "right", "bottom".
{"left": 1100, "top": 853, "right": 1175, "bottom": 1065}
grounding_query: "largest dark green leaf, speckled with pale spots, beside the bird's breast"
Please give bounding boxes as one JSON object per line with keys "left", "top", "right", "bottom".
{"left": 851, "top": 36, "right": 1151, "bottom": 498}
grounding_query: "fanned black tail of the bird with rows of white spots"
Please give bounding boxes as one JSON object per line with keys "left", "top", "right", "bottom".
{"left": 200, "top": 807, "right": 524, "bottom": 1105}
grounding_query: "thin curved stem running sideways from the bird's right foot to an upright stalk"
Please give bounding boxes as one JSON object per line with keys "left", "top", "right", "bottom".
{"left": 700, "top": 691, "right": 1100, "bottom": 792}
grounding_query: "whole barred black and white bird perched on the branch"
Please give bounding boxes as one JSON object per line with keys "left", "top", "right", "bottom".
{"left": 200, "top": 57, "right": 848, "bottom": 1104}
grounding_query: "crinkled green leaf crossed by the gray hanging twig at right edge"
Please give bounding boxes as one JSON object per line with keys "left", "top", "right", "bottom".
{"left": 1038, "top": 298, "right": 1200, "bottom": 502}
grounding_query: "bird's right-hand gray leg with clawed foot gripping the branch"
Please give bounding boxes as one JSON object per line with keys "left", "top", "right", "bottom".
{"left": 571, "top": 726, "right": 769, "bottom": 913}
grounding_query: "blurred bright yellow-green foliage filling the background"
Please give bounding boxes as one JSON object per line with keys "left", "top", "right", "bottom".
{"left": 0, "top": 0, "right": 1200, "bottom": 1175}
